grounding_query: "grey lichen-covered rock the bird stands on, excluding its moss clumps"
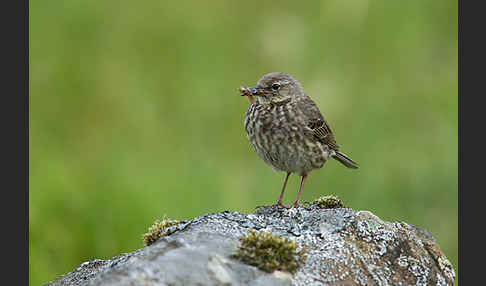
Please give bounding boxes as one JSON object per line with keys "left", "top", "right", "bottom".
{"left": 46, "top": 205, "right": 455, "bottom": 286}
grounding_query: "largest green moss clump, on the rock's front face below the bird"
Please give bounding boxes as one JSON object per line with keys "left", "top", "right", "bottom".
{"left": 233, "top": 230, "right": 307, "bottom": 273}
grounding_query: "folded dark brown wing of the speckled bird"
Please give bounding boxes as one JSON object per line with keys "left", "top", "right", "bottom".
{"left": 300, "top": 96, "right": 339, "bottom": 151}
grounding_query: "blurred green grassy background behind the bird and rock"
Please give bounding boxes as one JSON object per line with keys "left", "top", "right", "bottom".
{"left": 29, "top": 0, "right": 460, "bottom": 285}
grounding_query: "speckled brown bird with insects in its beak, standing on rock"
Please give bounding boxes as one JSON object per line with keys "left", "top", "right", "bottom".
{"left": 239, "top": 72, "right": 359, "bottom": 208}
